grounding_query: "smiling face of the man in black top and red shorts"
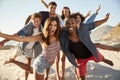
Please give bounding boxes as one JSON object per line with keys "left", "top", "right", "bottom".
{"left": 66, "top": 18, "right": 76, "bottom": 33}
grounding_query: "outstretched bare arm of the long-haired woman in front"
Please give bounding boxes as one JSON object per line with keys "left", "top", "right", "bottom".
{"left": 0, "top": 32, "right": 42, "bottom": 42}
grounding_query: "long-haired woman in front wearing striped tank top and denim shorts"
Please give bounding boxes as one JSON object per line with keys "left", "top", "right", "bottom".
{"left": 0, "top": 17, "right": 60, "bottom": 80}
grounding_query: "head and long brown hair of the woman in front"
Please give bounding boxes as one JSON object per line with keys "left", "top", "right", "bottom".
{"left": 43, "top": 17, "right": 60, "bottom": 38}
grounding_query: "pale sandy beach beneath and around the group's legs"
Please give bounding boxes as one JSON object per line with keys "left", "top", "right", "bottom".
{"left": 0, "top": 49, "right": 120, "bottom": 80}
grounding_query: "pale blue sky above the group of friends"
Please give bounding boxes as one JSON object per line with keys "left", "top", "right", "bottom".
{"left": 0, "top": 0, "right": 120, "bottom": 34}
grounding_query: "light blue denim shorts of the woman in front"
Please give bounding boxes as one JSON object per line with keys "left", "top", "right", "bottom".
{"left": 33, "top": 55, "right": 52, "bottom": 74}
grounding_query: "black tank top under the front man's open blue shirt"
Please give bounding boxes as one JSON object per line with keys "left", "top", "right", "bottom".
{"left": 68, "top": 40, "right": 92, "bottom": 59}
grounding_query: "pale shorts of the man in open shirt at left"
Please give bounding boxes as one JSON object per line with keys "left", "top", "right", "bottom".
{"left": 14, "top": 43, "right": 33, "bottom": 58}
